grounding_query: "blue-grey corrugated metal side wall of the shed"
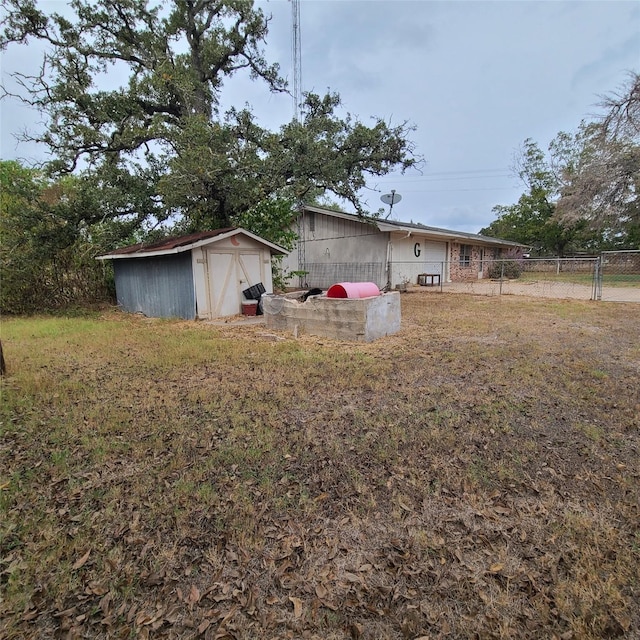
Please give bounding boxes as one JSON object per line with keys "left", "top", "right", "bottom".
{"left": 113, "top": 251, "right": 196, "bottom": 320}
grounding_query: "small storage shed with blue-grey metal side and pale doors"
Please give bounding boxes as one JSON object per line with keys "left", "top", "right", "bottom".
{"left": 98, "top": 227, "right": 287, "bottom": 320}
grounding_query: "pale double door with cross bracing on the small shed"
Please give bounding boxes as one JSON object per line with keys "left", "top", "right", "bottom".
{"left": 207, "top": 251, "right": 261, "bottom": 318}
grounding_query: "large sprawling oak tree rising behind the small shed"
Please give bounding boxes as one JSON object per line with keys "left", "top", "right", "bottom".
{"left": 2, "top": 0, "right": 419, "bottom": 239}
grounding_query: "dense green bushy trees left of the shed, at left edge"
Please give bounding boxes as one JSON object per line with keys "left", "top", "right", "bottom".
{"left": 0, "top": 161, "right": 113, "bottom": 313}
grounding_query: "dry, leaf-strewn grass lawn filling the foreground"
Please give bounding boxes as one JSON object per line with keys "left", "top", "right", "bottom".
{"left": 0, "top": 291, "right": 640, "bottom": 640}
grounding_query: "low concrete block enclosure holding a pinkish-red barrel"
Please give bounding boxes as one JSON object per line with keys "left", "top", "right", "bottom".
{"left": 263, "top": 291, "right": 401, "bottom": 342}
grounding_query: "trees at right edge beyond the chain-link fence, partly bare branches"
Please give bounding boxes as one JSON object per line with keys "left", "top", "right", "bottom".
{"left": 480, "top": 74, "right": 640, "bottom": 255}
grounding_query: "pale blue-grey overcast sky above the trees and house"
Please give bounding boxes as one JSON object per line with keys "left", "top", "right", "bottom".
{"left": 1, "top": 0, "right": 640, "bottom": 232}
